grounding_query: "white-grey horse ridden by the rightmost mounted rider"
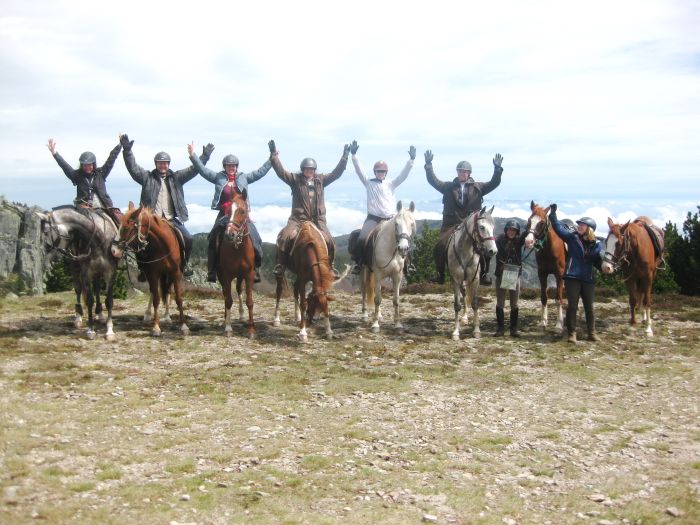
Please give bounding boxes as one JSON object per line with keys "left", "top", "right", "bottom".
{"left": 447, "top": 206, "right": 497, "bottom": 341}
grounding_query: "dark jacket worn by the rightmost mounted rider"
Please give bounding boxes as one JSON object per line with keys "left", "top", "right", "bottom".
{"left": 425, "top": 163, "right": 503, "bottom": 231}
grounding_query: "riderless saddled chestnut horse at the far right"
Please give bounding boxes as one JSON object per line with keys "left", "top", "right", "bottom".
{"left": 601, "top": 216, "right": 660, "bottom": 337}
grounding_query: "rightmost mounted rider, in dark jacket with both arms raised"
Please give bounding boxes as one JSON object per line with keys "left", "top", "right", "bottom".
{"left": 425, "top": 150, "right": 503, "bottom": 286}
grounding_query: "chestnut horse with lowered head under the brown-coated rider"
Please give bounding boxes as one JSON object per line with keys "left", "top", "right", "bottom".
{"left": 273, "top": 221, "right": 333, "bottom": 343}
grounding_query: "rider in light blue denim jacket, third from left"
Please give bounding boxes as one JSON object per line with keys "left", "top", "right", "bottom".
{"left": 187, "top": 144, "right": 272, "bottom": 283}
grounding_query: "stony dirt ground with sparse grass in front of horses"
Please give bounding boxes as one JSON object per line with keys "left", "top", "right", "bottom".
{"left": 0, "top": 289, "right": 700, "bottom": 525}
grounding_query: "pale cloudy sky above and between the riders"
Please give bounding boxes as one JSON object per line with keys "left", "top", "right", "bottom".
{"left": 0, "top": 0, "right": 700, "bottom": 241}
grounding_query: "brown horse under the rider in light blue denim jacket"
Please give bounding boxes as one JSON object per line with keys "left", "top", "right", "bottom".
{"left": 217, "top": 190, "right": 255, "bottom": 339}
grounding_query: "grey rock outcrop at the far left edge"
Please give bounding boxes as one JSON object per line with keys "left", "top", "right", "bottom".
{"left": 0, "top": 196, "right": 47, "bottom": 295}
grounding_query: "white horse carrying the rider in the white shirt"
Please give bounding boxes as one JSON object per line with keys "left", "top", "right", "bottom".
{"left": 361, "top": 201, "right": 416, "bottom": 332}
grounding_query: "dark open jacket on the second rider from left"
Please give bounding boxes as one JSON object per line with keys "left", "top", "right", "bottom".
{"left": 124, "top": 148, "right": 209, "bottom": 222}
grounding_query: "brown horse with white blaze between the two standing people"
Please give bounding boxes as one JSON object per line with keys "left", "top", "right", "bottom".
{"left": 524, "top": 201, "right": 566, "bottom": 334}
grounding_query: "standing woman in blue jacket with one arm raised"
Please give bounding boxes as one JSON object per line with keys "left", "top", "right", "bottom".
{"left": 549, "top": 204, "right": 602, "bottom": 343}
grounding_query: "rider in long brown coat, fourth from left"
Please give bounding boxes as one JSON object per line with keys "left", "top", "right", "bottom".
{"left": 268, "top": 140, "right": 350, "bottom": 277}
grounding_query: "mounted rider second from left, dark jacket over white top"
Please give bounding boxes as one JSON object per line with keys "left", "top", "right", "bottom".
{"left": 119, "top": 133, "right": 214, "bottom": 280}
